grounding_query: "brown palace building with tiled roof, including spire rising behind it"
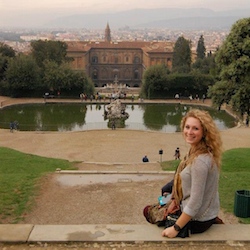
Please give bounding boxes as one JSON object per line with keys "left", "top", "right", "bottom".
{"left": 67, "top": 24, "right": 174, "bottom": 87}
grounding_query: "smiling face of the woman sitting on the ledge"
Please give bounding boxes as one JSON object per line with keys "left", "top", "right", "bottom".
{"left": 183, "top": 117, "right": 203, "bottom": 146}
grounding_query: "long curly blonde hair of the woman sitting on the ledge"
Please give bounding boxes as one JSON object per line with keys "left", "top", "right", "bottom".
{"left": 181, "top": 109, "right": 222, "bottom": 167}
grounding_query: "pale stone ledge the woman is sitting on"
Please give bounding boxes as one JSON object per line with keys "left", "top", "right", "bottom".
{"left": 0, "top": 224, "right": 250, "bottom": 245}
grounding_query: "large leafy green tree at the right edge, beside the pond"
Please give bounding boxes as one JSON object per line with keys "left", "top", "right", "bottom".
{"left": 209, "top": 18, "right": 250, "bottom": 115}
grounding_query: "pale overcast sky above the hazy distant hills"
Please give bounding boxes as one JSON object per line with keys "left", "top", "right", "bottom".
{"left": 0, "top": 0, "right": 250, "bottom": 26}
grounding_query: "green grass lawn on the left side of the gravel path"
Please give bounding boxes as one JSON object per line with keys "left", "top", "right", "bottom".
{"left": 0, "top": 148, "right": 72, "bottom": 224}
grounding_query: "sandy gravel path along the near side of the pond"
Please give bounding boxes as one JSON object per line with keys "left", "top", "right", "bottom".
{"left": 0, "top": 127, "right": 250, "bottom": 164}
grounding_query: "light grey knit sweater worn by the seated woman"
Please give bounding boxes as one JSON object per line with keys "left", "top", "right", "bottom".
{"left": 180, "top": 154, "right": 220, "bottom": 221}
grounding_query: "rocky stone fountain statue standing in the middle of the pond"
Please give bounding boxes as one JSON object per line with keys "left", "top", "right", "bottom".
{"left": 104, "top": 99, "right": 129, "bottom": 129}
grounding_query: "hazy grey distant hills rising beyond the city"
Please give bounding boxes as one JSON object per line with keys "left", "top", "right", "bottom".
{"left": 44, "top": 8, "right": 250, "bottom": 30}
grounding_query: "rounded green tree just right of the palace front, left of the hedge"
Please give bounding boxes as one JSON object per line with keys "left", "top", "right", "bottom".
{"left": 142, "top": 64, "right": 169, "bottom": 99}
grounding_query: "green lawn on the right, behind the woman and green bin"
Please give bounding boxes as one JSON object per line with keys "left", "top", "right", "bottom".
{"left": 162, "top": 148, "right": 250, "bottom": 224}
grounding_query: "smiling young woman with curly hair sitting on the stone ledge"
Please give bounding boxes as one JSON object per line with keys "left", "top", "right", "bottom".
{"left": 162, "top": 109, "right": 222, "bottom": 238}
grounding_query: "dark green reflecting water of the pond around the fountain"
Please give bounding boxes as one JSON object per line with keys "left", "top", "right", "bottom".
{"left": 0, "top": 103, "right": 235, "bottom": 133}
